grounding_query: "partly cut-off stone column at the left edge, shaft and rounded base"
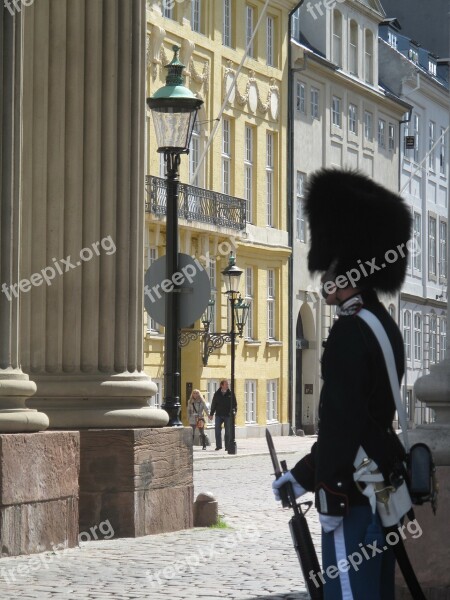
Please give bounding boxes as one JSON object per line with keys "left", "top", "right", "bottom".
{"left": 0, "top": 6, "right": 48, "bottom": 433}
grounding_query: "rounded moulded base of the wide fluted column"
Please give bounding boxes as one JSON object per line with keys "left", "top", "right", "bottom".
{"left": 27, "top": 373, "right": 169, "bottom": 429}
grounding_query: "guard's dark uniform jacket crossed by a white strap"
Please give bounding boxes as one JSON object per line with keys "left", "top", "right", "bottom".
{"left": 291, "top": 290, "right": 404, "bottom": 516}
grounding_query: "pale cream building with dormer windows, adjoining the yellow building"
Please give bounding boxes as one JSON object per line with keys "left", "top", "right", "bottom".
{"left": 291, "top": 0, "right": 409, "bottom": 433}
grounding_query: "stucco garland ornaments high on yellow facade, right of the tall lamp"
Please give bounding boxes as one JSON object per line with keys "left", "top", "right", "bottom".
{"left": 223, "top": 61, "right": 280, "bottom": 121}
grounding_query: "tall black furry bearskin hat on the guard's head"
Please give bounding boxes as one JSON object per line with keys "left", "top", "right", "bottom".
{"left": 305, "top": 169, "right": 411, "bottom": 293}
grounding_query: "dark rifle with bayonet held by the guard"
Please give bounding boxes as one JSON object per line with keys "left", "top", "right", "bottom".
{"left": 266, "top": 429, "right": 323, "bottom": 600}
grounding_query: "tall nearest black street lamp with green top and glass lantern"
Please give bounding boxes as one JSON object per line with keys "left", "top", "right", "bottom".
{"left": 147, "top": 46, "right": 203, "bottom": 426}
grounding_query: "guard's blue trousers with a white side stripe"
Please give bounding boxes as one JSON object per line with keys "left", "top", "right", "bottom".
{"left": 322, "top": 506, "right": 395, "bottom": 600}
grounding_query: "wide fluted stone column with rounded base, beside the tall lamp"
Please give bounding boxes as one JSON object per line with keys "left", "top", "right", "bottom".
{"left": 21, "top": 0, "right": 168, "bottom": 429}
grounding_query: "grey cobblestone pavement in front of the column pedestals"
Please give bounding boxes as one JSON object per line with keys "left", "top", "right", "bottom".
{"left": 0, "top": 437, "right": 319, "bottom": 600}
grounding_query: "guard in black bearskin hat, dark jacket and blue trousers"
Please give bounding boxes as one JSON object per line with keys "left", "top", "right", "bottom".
{"left": 274, "top": 169, "right": 411, "bottom": 600}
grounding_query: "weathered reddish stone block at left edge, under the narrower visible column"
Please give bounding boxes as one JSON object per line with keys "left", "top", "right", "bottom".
{"left": 0, "top": 431, "right": 80, "bottom": 556}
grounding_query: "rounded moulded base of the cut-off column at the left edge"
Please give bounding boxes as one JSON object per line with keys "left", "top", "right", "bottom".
{"left": 0, "top": 369, "right": 49, "bottom": 433}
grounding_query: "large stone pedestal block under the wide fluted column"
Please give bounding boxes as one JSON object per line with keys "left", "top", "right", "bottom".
{"left": 80, "top": 427, "right": 193, "bottom": 538}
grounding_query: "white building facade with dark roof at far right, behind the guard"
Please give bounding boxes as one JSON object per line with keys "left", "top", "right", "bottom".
{"left": 379, "top": 19, "right": 449, "bottom": 424}
